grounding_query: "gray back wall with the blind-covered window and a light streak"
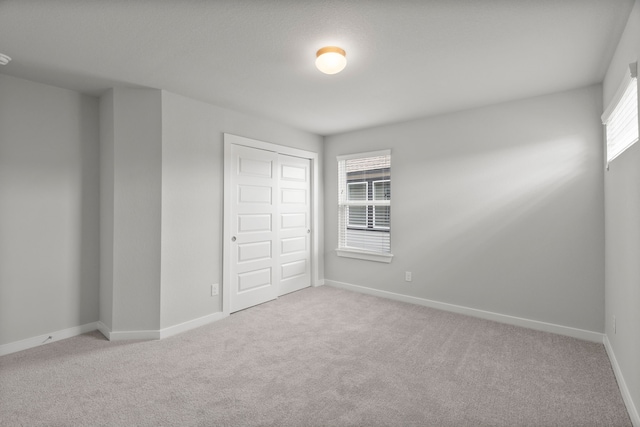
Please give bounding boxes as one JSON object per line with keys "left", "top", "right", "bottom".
{"left": 325, "top": 86, "right": 604, "bottom": 332}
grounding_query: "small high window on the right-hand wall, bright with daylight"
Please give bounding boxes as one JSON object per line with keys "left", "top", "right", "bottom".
{"left": 602, "top": 63, "right": 638, "bottom": 167}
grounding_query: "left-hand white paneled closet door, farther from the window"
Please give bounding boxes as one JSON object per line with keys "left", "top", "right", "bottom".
{"left": 229, "top": 144, "right": 280, "bottom": 312}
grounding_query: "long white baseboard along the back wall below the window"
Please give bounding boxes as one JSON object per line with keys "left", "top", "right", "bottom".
{"left": 325, "top": 279, "right": 604, "bottom": 343}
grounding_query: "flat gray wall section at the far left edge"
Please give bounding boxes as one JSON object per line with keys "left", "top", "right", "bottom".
{"left": 0, "top": 75, "right": 99, "bottom": 344}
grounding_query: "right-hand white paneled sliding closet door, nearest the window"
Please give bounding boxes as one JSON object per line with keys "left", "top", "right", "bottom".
{"left": 278, "top": 154, "right": 311, "bottom": 295}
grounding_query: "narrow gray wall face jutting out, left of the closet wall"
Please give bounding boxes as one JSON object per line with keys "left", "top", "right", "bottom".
{"left": 109, "top": 88, "right": 162, "bottom": 331}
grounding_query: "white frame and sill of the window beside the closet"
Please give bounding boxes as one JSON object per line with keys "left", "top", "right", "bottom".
{"left": 336, "top": 150, "right": 393, "bottom": 263}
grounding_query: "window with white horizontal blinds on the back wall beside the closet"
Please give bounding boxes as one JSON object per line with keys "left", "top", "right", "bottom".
{"left": 337, "top": 150, "right": 393, "bottom": 262}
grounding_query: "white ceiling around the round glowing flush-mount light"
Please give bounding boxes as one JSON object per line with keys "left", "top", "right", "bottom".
{"left": 0, "top": 0, "right": 634, "bottom": 135}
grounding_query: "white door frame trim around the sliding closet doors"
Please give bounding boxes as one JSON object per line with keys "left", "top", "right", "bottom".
{"left": 222, "top": 133, "right": 321, "bottom": 315}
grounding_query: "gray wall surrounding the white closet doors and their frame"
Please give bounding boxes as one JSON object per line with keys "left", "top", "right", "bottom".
{"left": 161, "top": 91, "right": 323, "bottom": 328}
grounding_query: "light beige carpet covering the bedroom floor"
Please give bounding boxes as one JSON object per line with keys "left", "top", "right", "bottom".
{"left": 0, "top": 286, "right": 631, "bottom": 427}
